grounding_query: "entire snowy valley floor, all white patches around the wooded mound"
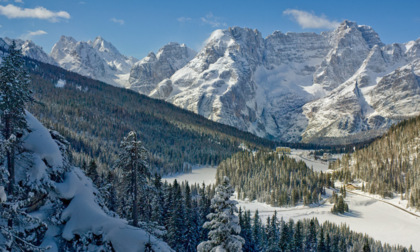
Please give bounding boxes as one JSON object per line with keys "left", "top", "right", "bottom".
{"left": 164, "top": 152, "right": 420, "bottom": 251}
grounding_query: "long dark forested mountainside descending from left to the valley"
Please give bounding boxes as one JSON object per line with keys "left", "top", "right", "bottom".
{"left": 22, "top": 58, "right": 274, "bottom": 174}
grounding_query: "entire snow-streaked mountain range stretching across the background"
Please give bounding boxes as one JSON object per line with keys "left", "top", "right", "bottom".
{"left": 4, "top": 21, "right": 420, "bottom": 143}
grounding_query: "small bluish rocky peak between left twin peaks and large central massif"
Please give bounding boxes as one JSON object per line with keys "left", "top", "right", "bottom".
{"left": 129, "top": 43, "right": 196, "bottom": 95}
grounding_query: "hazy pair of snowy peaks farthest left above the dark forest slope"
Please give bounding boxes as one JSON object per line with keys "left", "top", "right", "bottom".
{"left": 50, "top": 36, "right": 137, "bottom": 87}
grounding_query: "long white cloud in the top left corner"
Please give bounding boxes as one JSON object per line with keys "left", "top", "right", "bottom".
{"left": 0, "top": 4, "right": 70, "bottom": 22}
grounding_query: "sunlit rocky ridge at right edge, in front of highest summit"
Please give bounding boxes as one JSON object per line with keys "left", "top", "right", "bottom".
{"left": 302, "top": 34, "right": 420, "bottom": 142}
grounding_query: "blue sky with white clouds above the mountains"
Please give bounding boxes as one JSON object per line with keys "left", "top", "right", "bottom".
{"left": 0, "top": 0, "right": 420, "bottom": 59}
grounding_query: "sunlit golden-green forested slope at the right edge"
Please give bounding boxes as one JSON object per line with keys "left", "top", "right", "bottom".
{"left": 330, "top": 117, "right": 420, "bottom": 209}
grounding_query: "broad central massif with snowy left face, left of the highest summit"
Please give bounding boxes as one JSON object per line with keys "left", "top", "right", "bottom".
{"left": 150, "top": 27, "right": 329, "bottom": 141}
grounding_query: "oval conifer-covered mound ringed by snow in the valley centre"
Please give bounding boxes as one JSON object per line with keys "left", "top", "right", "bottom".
{"left": 216, "top": 151, "right": 333, "bottom": 206}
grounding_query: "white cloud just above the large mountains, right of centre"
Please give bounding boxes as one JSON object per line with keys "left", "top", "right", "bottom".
{"left": 283, "top": 9, "right": 340, "bottom": 29}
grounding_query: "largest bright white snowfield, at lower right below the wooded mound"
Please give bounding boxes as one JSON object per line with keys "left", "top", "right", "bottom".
{"left": 239, "top": 193, "right": 420, "bottom": 251}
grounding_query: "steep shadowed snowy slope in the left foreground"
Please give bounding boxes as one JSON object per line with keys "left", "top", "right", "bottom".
{"left": 0, "top": 113, "right": 171, "bottom": 251}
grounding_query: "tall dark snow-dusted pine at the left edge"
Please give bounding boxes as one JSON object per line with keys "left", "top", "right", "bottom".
{"left": 0, "top": 42, "right": 47, "bottom": 251}
